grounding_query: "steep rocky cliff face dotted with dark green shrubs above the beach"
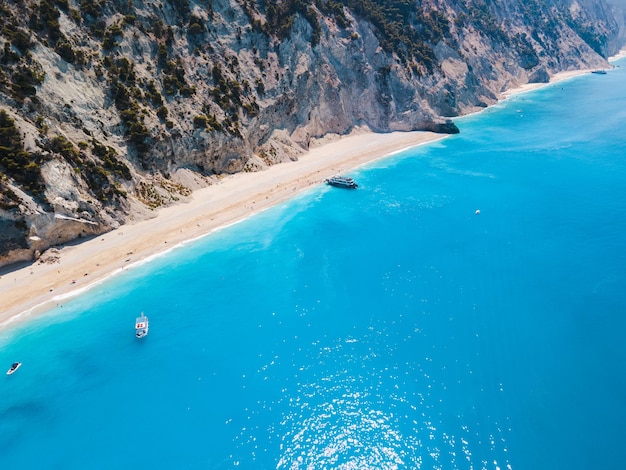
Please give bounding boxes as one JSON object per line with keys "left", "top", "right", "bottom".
{"left": 0, "top": 0, "right": 625, "bottom": 265}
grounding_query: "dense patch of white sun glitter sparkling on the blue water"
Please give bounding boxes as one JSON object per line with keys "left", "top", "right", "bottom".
{"left": 232, "top": 328, "right": 510, "bottom": 470}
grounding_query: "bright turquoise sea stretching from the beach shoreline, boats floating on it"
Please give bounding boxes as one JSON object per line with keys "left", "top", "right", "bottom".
{"left": 0, "top": 60, "right": 626, "bottom": 469}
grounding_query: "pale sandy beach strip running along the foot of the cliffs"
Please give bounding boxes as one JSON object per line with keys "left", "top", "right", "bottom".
{"left": 0, "top": 51, "right": 626, "bottom": 328}
